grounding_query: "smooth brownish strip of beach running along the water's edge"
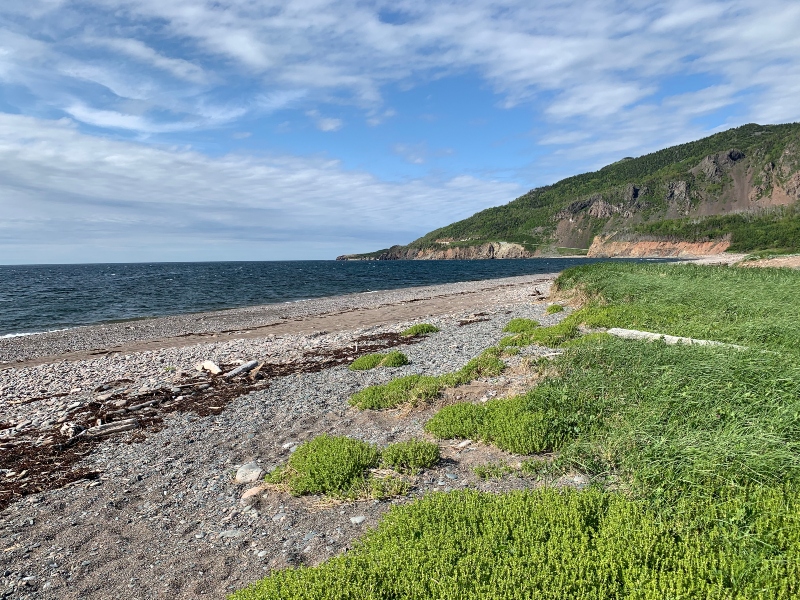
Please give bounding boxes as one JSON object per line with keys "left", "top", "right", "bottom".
{"left": 0, "top": 273, "right": 558, "bottom": 371}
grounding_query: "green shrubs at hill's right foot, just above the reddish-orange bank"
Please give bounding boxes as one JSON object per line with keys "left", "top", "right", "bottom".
{"left": 634, "top": 207, "right": 800, "bottom": 253}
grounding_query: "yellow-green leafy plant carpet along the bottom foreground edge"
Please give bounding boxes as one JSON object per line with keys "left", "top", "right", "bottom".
{"left": 231, "top": 487, "right": 800, "bottom": 600}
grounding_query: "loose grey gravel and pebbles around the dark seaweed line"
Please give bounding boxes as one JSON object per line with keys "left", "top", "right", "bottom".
{"left": 0, "top": 277, "right": 585, "bottom": 599}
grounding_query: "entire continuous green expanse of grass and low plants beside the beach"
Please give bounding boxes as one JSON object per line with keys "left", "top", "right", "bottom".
{"left": 239, "top": 266, "right": 800, "bottom": 600}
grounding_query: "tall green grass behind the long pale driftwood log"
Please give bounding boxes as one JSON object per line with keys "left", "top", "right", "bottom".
{"left": 545, "top": 263, "right": 800, "bottom": 354}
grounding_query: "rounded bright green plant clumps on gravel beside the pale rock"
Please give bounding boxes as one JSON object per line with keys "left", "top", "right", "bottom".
{"left": 265, "top": 434, "right": 439, "bottom": 499}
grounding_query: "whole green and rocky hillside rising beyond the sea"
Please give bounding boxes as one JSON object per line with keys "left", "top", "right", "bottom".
{"left": 339, "top": 123, "right": 800, "bottom": 260}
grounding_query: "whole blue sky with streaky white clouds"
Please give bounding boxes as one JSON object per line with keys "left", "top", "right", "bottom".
{"left": 0, "top": 0, "right": 800, "bottom": 264}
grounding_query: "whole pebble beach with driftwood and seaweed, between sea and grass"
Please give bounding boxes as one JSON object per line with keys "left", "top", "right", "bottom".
{"left": 0, "top": 274, "right": 582, "bottom": 599}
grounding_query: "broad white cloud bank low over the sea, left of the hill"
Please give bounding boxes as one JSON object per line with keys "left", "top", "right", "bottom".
{"left": 0, "top": 115, "right": 523, "bottom": 263}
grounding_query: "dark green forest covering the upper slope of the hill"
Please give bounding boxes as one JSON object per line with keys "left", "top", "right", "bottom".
{"left": 382, "top": 123, "right": 800, "bottom": 252}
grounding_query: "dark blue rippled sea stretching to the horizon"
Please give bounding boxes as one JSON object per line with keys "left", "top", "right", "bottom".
{"left": 0, "top": 258, "right": 644, "bottom": 336}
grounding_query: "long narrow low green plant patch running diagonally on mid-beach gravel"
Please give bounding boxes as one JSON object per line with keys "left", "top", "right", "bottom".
{"left": 349, "top": 348, "right": 505, "bottom": 410}
